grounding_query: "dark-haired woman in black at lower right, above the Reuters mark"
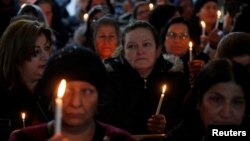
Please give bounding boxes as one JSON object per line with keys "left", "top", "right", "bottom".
{"left": 165, "top": 59, "right": 250, "bottom": 141}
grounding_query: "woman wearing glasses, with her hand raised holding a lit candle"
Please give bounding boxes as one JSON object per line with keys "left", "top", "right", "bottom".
{"left": 162, "top": 17, "right": 205, "bottom": 82}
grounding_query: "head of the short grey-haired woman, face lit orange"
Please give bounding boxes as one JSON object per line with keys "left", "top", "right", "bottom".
{"left": 93, "top": 17, "right": 120, "bottom": 60}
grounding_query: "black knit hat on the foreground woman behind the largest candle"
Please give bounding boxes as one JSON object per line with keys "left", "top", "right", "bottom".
{"left": 37, "top": 45, "right": 106, "bottom": 98}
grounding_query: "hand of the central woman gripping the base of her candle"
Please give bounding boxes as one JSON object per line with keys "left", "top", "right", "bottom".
{"left": 147, "top": 114, "right": 167, "bottom": 133}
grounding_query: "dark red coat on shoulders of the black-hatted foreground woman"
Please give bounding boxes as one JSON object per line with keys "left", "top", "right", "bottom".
{"left": 8, "top": 122, "right": 134, "bottom": 141}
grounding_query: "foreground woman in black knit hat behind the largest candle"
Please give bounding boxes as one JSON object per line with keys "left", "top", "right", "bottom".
{"left": 9, "top": 46, "right": 133, "bottom": 141}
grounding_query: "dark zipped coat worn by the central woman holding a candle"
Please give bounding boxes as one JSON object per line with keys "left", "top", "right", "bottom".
{"left": 98, "top": 57, "right": 189, "bottom": 134}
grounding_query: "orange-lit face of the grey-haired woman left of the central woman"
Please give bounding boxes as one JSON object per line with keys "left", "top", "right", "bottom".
{"left": 95, "top": 25, "right": 118, "bottom": 59}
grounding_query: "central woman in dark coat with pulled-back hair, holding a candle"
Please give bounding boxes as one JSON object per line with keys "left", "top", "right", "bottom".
{"left": 99, "top": 21, "right": 188, "bottom": 134}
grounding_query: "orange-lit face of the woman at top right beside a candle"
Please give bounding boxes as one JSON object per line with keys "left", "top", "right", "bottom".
{"left": 197, "top": 1, "right": 218, "bottom": 25}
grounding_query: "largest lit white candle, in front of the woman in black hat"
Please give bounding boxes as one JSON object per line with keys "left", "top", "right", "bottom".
{"left": 55, "top": 79, "right": 66, "bottom": 134}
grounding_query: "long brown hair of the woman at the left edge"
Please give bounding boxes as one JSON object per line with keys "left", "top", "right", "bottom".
{"left": 0, "top": 20, "right": 52, "bottom": 86}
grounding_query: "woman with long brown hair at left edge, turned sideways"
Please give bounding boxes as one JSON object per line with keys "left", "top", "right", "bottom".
{"left": 0, "top": 19, "right": 52, "bottom": 140}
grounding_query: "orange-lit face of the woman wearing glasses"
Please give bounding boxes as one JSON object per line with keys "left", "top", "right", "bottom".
{"left": 165, "top": 23, "right": 189, "bottom": 57}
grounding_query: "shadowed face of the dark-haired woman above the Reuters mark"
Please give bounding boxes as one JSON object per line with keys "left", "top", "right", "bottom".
{"left": 199, "top": 82, "right": 246, "bottom": 127}
